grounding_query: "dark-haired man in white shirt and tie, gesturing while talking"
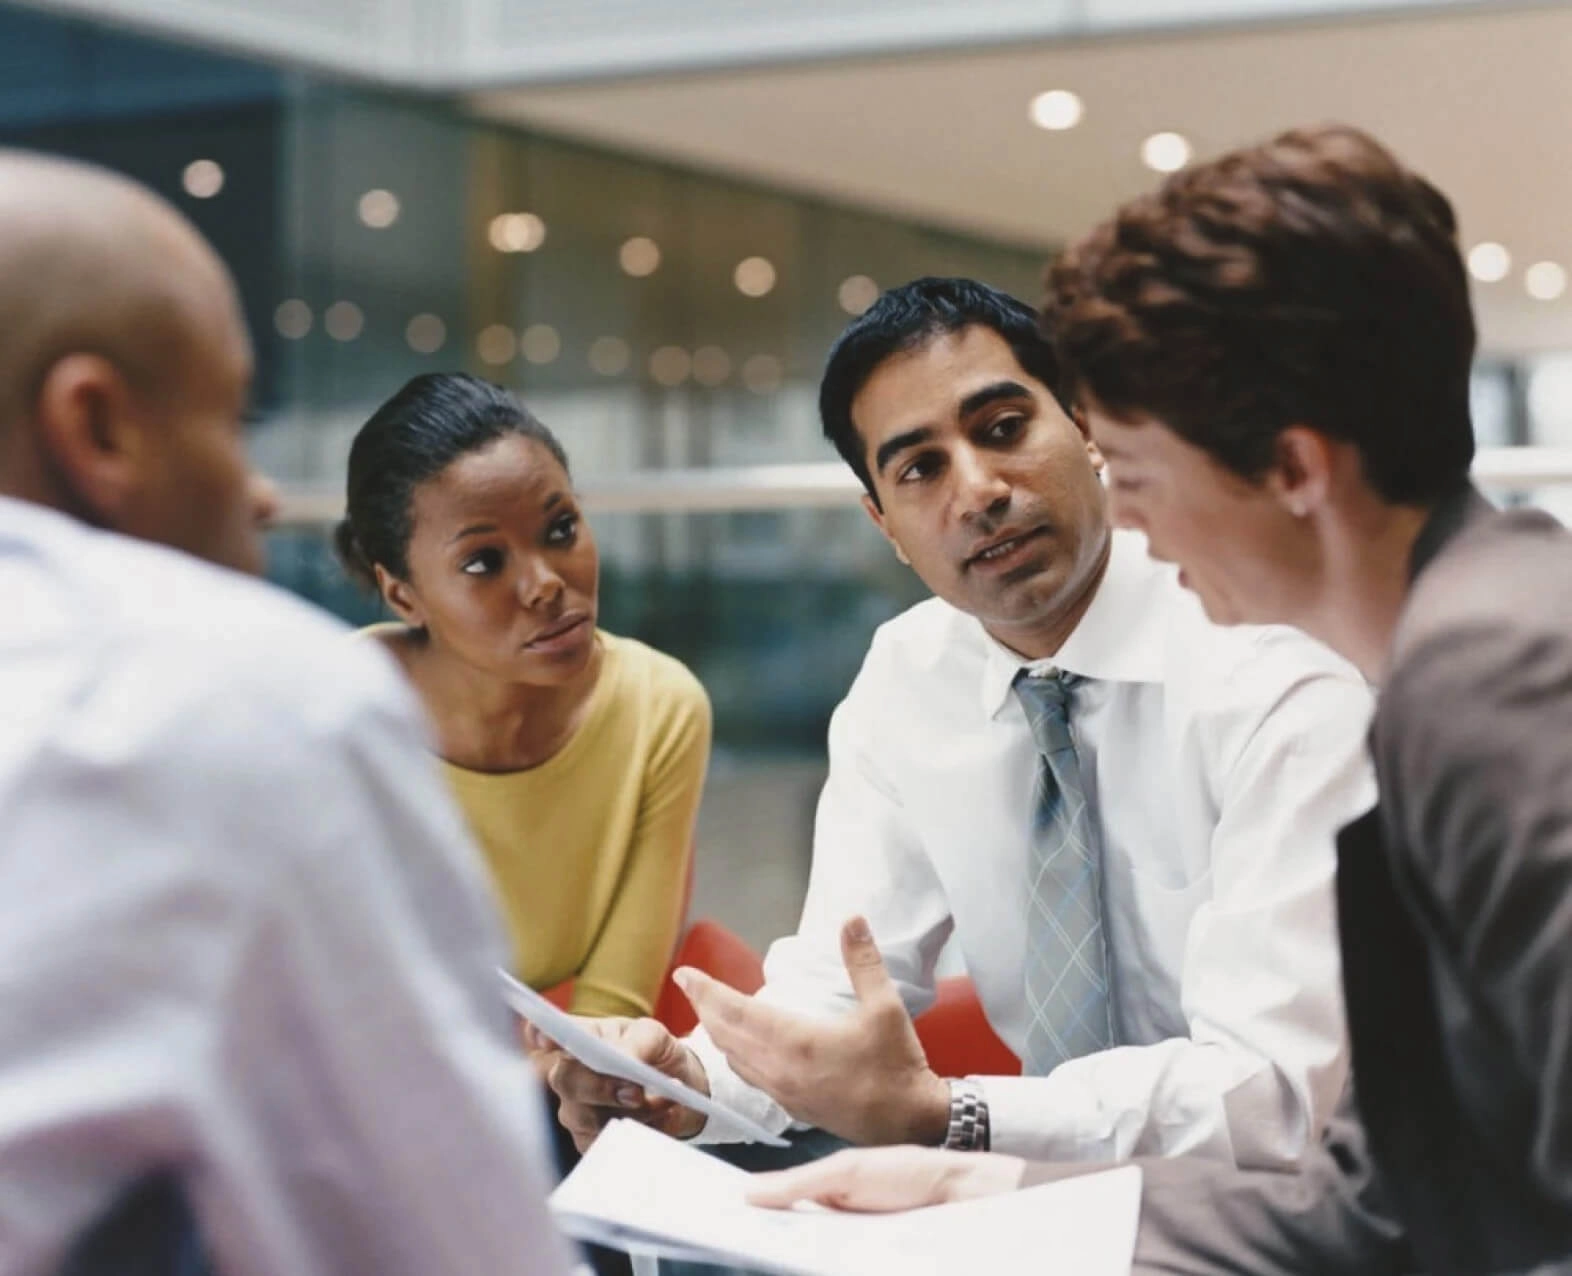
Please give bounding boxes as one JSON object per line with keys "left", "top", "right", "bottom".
{"left": 549, "top": 280, "right": 1374, "bottom": 1168}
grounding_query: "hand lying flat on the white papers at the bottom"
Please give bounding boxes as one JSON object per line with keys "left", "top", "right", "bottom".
{"left": 748, "top": 1147, "right": 1027, "bottom": 1213}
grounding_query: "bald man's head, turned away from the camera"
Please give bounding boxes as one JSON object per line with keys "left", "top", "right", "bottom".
{"left": 0, "top": 149, "right": 270, "bottom": 570}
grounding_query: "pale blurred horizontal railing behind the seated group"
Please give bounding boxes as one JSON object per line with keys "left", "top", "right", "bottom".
{"left": 278, "top": 448, "right": 1572, "bottom": 528}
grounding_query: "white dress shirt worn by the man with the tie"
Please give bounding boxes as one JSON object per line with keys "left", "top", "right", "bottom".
{"left": 692, "top": 531, "right": 1376, "bottom": 1166}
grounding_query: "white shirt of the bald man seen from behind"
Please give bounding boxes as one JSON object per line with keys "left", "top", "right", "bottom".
{"left": 0, "top": 500, "right": 572, "bottom": 1276}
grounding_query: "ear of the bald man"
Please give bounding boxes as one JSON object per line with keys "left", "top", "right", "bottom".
{"left": 33, "top": 354, "right": 154, "bottom": 530}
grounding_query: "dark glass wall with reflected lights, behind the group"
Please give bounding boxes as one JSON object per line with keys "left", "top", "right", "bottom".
{"left": 0, "top": 3, "right": 1572, "bottom": 941}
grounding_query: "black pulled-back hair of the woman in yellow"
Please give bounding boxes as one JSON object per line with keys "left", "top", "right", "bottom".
{"left": 333, "top": 372, "right": 567, "bottom": 589}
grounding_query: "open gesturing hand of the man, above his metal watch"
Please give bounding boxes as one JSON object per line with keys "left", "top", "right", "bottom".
{"left": 674, "top": 918, "right": 949, "bottom": 1144}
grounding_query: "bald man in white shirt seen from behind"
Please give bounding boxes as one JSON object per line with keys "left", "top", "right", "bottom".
{"left": 0, "top": 151, "right": 571, "bottom": 1276}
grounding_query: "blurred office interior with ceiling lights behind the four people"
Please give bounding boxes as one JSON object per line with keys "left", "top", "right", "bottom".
{"left": 0, "top": 0, "right": 1572, "bottom": 944}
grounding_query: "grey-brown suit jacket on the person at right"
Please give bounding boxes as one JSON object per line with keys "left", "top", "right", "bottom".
{"left": 1106, "top": 489, "right": 1572, "bottom": 1276}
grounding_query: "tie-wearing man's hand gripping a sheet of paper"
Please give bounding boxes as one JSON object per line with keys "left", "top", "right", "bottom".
{"left": 523, "top": 1018, "right": 709, "bottom": 1152}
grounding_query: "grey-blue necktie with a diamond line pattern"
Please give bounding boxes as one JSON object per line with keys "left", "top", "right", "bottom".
{"left": 1014, "top": 673, "right": 1113, "bottom": 1076}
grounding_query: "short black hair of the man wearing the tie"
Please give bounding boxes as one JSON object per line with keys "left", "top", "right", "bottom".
{"left": 819, "top": 277, "right": 1060, "bottom": 503}
